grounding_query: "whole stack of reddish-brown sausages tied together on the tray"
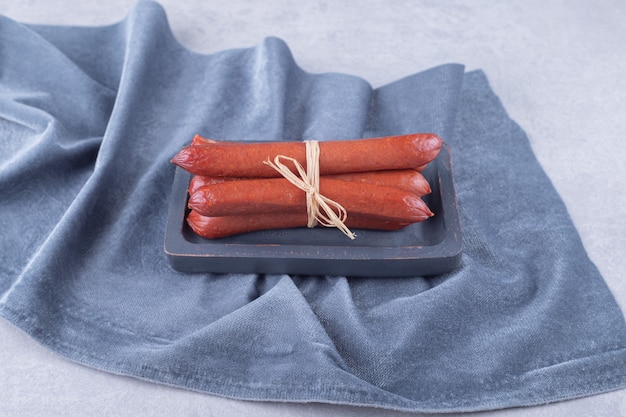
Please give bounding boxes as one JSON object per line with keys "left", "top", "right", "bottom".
{"left": 171, "top": 134, "right": 442, "bottom": 239}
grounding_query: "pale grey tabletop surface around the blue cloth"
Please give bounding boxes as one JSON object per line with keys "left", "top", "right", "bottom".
{"left": 0, "top": 0, "right": 626, "bottom": 417}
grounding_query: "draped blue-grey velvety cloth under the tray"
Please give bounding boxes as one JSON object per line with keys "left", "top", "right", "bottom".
{"left": 0, "top": 1, "right": 626, "bottom": 412}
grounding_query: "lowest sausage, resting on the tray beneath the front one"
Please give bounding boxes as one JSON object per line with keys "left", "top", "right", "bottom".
{"left": 187, "top": 210, "right": 409, "bottom": 239}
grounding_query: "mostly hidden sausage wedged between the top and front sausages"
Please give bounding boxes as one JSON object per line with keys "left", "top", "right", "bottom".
{"left": 189, "top": 169, "right": 432, "bottom": 197}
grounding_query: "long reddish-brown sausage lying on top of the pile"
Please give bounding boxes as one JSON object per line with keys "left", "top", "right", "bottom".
{"left": 171, "top": 133, "right": 442, "bottom": 177}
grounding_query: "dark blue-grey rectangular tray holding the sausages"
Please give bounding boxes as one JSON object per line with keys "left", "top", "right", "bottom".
{"left": 164, "top": 144, "right": 462, "bottom": 277}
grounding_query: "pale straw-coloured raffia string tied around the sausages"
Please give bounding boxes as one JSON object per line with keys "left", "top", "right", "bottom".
{"left": 264, "top": 140, "right": 356, "bottom": 239}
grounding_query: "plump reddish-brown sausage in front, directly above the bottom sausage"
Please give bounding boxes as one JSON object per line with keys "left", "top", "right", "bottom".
{"left": 188, "top": 178, "right": 433, "bottom": 223}
